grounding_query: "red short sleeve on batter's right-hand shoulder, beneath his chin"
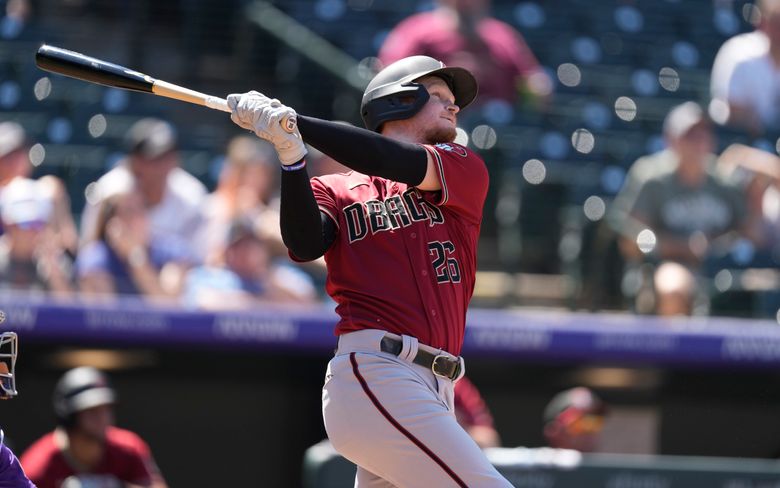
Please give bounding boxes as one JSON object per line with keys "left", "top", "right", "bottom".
{"left": 423, "top": 143, "right": 489, "bottom": 223}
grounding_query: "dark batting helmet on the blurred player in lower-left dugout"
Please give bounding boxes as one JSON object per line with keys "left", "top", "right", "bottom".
{"left": 53, "top": 366, "right": 116, "bottom": 425}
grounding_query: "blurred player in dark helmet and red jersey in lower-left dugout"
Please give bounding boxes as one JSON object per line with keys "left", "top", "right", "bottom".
{"left": 21, "top": 367, "right": 166, "bottom": 488}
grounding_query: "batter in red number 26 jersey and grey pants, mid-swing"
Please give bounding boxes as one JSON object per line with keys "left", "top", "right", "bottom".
{"left": 228, "top": 56, "right": 511, "bottom": 488}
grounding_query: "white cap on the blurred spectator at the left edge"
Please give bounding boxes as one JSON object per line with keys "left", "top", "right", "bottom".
{"left": 0, "top": 178, "right": 52, "bottom": 225}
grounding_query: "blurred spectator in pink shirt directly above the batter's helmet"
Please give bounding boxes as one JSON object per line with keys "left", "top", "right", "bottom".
{"left": 379, "top": 0, "right": 552, "bottom": 104}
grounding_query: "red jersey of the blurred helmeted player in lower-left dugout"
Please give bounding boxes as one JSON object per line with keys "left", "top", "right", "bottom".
{"left": 20, "top": 427, "right": 162, "bottom": 488}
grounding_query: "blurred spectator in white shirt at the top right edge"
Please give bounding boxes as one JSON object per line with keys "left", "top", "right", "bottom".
{"left": 713, "top": 0, "right": 780, "bottom": 134}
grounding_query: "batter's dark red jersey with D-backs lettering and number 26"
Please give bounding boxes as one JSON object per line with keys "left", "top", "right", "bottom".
{"left": 304, "top": 143, "right": 488, "bottom": 355}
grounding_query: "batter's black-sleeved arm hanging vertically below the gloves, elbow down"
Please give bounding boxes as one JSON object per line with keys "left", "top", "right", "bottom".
{"left": 279, "top": 168, "right": 326, "bottom": 261}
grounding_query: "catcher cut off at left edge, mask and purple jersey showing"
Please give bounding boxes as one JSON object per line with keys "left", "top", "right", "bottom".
{"left": 0, "top": 332, "right": 35, "bottom": 488}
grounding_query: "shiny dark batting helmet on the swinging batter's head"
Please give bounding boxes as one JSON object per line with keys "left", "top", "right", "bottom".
{"left": 360, "top": 56, "right": 478, "bottom": 132}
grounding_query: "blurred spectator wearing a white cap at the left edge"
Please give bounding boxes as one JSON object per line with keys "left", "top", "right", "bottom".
{"left": 0, "top": 178, "right": 72, "bottom": 294}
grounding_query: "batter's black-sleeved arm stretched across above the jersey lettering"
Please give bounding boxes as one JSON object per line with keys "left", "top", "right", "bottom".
{"left": 298, "top": 115, "right": 428, "bottom": 185}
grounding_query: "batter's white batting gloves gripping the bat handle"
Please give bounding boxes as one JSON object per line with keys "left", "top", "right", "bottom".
{"left": 227, "top": 91, "right": 307, "bottom": 166}
